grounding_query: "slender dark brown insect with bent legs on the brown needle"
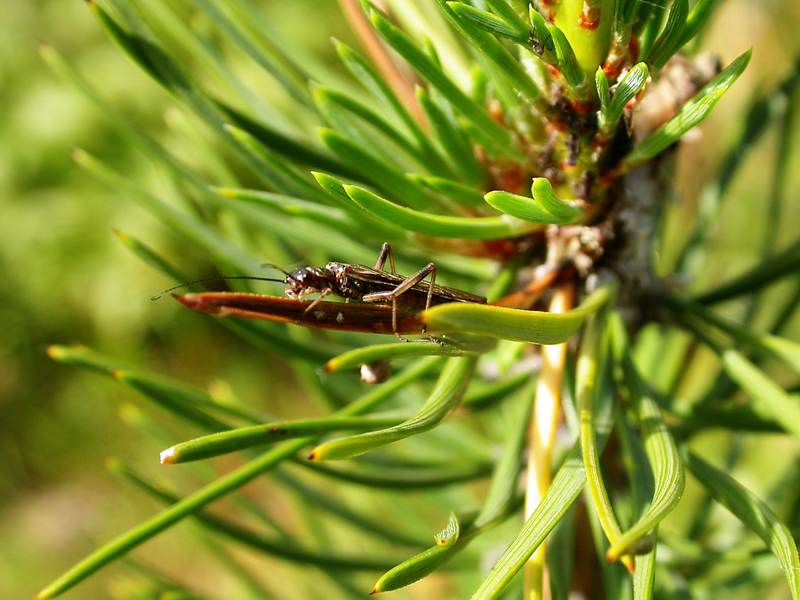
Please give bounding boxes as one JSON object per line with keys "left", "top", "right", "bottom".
{"left": 283, "top": 242, "right": 486, "bottom": 335}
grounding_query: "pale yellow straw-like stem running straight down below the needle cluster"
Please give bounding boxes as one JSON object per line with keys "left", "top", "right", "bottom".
{"left": 524, "top": 282, "right": 575, "bottom": 600}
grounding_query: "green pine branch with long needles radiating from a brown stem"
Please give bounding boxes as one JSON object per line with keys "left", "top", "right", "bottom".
{"left": 39, "top": 0, "right": 800, "bottom": 599}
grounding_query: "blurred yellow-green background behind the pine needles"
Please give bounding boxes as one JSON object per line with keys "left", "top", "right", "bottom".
{"left": 0, "top": 0, "right": 800, "bottom": 598}
